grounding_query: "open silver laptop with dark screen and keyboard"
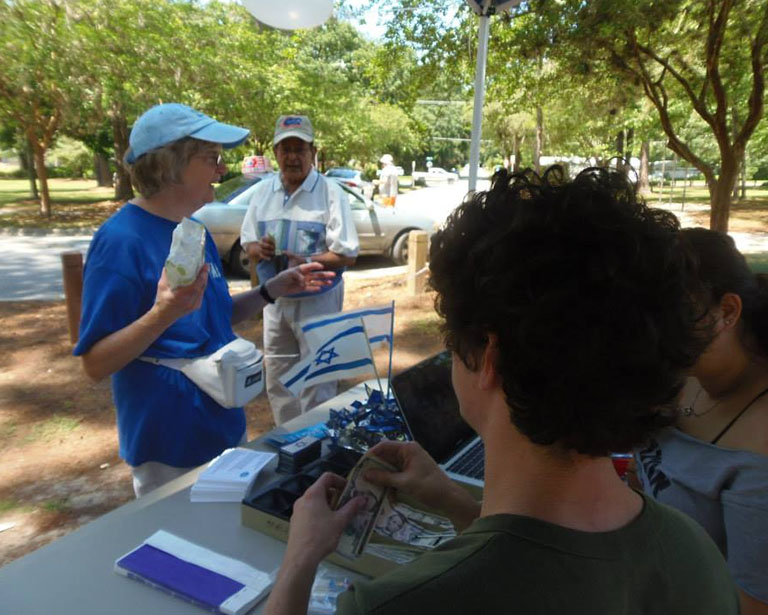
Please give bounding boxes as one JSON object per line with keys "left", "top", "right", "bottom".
{"left": 392, "top": 351, "right": 485, "bottom": 487}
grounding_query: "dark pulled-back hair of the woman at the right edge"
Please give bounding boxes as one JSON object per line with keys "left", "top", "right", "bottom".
{"left": 680, "top": 227, "right": 768, "bottom": 359}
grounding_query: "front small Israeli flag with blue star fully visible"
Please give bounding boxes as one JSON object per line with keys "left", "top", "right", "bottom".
{"left": 280, "top": 317, "right": 376, "bottom": 396}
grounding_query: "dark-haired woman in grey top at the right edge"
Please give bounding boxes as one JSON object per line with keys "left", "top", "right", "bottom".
{"left": 637, "top": 228, "right": 768, "bottom": 615}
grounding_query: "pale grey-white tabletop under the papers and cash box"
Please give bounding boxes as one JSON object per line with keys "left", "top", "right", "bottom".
{"left": 0, "top": 385, "right": 374, "bottom": 615}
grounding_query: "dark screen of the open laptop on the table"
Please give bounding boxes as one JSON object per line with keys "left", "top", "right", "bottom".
{"left": 392, "top": 350, "right": 475, "bottom": 463}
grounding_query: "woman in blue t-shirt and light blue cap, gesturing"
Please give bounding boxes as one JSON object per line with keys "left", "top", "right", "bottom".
{"left": 74, "top": 103, "right": 333, "bottom": 497}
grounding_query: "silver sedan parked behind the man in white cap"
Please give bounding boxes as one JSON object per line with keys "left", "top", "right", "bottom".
{"left": 195, "top": 175, "right": 439, "bottom": 277}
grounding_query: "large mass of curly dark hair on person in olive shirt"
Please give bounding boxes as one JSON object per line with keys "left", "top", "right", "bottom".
{"left": 430, "top": 167, "right": 708, "bottom": 456}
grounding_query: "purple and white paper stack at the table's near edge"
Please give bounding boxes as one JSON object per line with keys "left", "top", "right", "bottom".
{"left": 115, "top": 530, "right": 274, "bottom": 615}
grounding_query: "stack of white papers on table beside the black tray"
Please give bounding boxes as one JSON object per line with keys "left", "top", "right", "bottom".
{"left": 190, "top": 448, "right": 275, "bottom": 502}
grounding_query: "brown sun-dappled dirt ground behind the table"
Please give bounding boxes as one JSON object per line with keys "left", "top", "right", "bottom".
{"left": 0, "top": 276, "right": 442, "bottom": 566}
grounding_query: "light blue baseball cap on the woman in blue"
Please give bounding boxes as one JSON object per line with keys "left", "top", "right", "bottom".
{"left": 125, "top": 103, "right": 251, "bottom": 164}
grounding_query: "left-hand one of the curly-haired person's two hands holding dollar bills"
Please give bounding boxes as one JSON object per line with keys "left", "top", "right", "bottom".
{"left": 285, "top": 472, "right": 365, "bottom": 565}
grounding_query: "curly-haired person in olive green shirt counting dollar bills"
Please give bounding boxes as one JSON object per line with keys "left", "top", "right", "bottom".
{"left": 266, "top": 168, "right": 739, "bottom": 615}
